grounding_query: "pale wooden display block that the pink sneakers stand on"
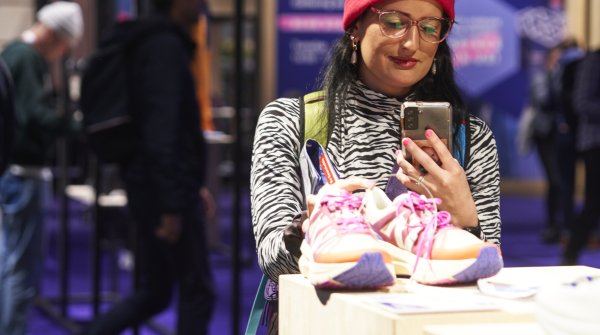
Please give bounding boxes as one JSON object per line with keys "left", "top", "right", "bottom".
{"left": 279, "top": 266, "right": 600, "bottom": 335}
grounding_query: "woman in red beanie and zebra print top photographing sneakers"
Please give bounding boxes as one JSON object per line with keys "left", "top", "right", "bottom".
{"left": 251, "top": 0, "right": 500, "bottom": 330}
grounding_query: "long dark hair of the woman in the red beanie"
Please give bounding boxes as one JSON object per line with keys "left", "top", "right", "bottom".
{"left": 321, "top": 26, "right": 468, "bottom": 155}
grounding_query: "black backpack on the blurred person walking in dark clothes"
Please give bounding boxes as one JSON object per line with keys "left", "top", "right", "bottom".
{"left": 80, "top": 21, "right": 172, "bottom": 163}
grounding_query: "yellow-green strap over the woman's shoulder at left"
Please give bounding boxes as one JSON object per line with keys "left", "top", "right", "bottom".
{"left": 300, "top": 91, "right": 329, "bottom": 147}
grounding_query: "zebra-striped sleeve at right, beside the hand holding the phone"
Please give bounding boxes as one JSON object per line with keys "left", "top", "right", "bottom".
{"left": 466, "top": 116, "right": 501, "bottom": 244}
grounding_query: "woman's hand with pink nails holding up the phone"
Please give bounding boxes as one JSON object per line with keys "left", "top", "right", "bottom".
{"left": 396, "top": 129, "right": 478, "bottom": 228}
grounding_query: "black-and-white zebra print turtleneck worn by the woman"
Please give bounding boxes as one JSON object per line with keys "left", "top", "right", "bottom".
{"left": 250, "top": 82, "right": 500, "bottom": 281}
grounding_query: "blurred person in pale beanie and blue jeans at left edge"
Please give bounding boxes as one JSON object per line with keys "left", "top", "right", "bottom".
{"left": 0, "top": 1, "right": 83, "bottom": 335}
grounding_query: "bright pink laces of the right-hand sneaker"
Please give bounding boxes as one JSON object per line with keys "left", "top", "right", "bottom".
{"left": 396, "top": 191, "right": 452, "bottom": 273}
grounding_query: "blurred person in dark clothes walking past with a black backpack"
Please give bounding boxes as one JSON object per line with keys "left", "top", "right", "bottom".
{"left": 85, "top": 0, "right": 215, "bottom": 335}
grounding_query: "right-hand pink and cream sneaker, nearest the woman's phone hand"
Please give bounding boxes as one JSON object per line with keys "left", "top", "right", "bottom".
{"left": 363, "top": 188, "right": 504, "bottom": 285}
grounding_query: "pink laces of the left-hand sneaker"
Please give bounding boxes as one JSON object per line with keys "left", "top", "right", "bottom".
{"left": 321, "top": 192, "right": 371, "bottom": 234}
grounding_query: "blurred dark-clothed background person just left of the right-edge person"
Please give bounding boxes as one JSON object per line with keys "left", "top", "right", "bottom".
{"left": 530, "top": 39, "right": 579, "bottom": 243}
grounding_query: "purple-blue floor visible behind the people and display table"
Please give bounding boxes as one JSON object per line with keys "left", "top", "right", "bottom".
{"left": 30, "top": 195, "right": 600, "bottom": 335}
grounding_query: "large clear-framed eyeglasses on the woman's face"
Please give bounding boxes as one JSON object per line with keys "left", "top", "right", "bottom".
{"left": 371, "top": 7, "right": 454, "bottom": 43}
